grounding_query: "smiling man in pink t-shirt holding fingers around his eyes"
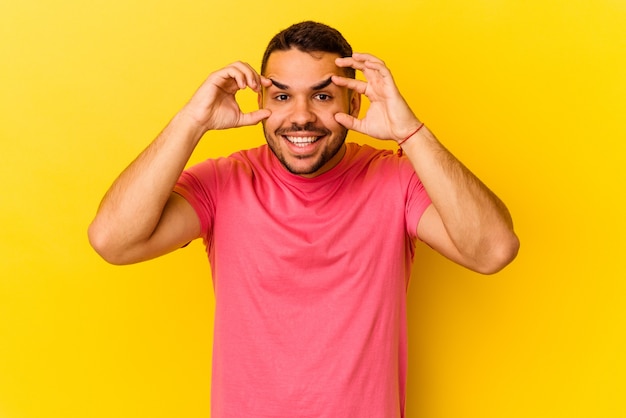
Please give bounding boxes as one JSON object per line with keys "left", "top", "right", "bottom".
{"left": 89, "top": 22, "right": 519, "bottom": 418}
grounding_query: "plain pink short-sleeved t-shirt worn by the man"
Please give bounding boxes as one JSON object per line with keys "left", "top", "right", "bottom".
{"left": 175, "top": 143, "right": 430, "bottom": 418}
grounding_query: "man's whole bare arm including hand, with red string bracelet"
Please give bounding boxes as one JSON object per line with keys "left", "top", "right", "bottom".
{"left": 333, "top": 54, "right": 519, "bottom": 274}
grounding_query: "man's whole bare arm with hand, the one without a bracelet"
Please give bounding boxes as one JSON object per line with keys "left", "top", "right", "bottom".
{"left": 88, "top": 62, "right": 271, "bottom": 264}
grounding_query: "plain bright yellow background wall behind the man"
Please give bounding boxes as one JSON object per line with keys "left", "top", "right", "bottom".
{"left": 0, "top": 0, "right": 626, "bottom": 418}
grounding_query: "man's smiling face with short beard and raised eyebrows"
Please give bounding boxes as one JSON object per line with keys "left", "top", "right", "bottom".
{"left": 259, "top": 49, "right": 360, "bottom": 177}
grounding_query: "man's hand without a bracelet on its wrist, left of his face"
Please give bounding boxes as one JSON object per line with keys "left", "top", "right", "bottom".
{"left": 181, "top": 62, "right": 272, "bottom": 132}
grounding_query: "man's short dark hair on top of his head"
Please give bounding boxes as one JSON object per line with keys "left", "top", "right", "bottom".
{"left": 261, "top": 21, "right": 356, "bottom": 78}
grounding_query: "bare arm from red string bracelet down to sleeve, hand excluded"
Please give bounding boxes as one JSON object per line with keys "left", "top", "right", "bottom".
{"left": 401, "top": 128, "right": 519, "bottom": 274}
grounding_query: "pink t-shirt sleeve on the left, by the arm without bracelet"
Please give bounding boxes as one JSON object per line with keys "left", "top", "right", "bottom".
{"left": 174, "top": 160, "right": 218, "bottom": 239}
